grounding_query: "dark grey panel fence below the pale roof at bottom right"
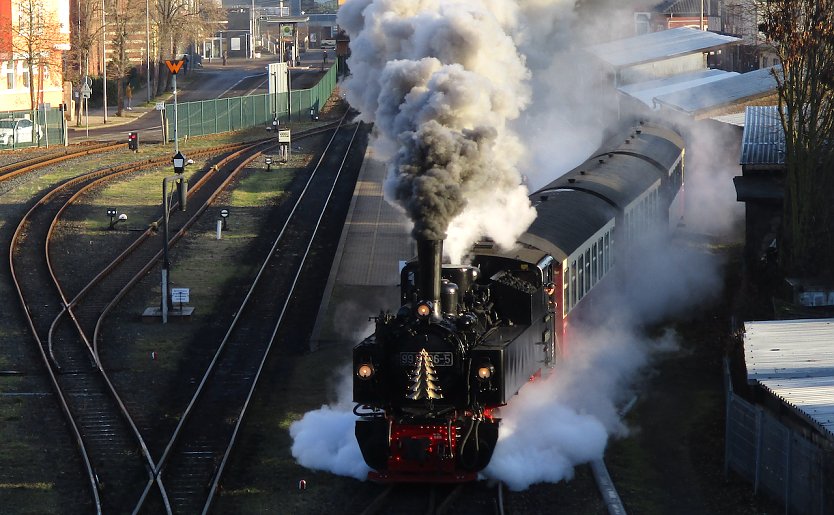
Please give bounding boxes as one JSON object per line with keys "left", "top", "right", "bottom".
{"left": 724, "top": 362, "right": 834, "bottom": 515}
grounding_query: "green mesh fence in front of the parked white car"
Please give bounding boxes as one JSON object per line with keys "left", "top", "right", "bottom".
{"left": 0, "top": 107, "right": 66, "bottom": 150}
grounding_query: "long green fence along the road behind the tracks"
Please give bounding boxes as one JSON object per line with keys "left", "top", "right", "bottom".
{"left": 165, "top": 62, "right": 338, "bottom": 141}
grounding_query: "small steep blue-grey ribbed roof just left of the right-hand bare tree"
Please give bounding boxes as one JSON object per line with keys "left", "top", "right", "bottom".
{"left": 739, "top": 106, "right": 785, "bottom": 165}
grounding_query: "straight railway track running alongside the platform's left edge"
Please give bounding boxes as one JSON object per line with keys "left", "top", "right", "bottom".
{"left": 134, "top": 115, "right": 359, "bottom": 513}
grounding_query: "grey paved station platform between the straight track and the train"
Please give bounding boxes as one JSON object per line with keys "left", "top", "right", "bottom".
{"left": 310, "top": 150, "right": 417, "bottom": 350}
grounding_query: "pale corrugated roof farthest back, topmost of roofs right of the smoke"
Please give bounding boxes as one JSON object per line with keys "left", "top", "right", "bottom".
{"left": 588, "top": 27, "right": 739, "bottom": 68}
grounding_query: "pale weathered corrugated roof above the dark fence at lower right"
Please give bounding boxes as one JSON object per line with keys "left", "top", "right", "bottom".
{"left": 744, "top": 318, "right": 834, "bottom": 438}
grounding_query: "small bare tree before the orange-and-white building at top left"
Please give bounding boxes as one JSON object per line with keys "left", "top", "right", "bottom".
{"left": 11, "top": 0, "right": 66, "bottom": 114}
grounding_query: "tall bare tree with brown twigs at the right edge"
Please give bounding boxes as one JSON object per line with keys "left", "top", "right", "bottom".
{"left": 758, "top": 0, "right": 834, "bottom": 277}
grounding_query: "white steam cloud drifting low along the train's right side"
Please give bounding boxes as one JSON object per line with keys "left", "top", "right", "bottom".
{"left": 483, "top": 233, "right": 721, "bottom": 490}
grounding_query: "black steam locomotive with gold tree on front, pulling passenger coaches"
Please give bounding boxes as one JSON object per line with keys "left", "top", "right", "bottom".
{"left": 353, "top": 122, "right": 684, "bottom": 483}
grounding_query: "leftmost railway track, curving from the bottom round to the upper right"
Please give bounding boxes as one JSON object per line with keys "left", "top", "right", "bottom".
{"left": 9, "top": 138, "right": 262, "bottom": 512}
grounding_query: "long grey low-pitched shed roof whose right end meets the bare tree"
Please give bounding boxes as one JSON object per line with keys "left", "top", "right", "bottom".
{"left": 655, "top": 68, "right": 777, "bottom": 116}
